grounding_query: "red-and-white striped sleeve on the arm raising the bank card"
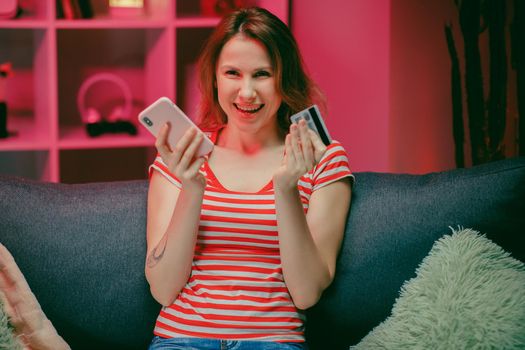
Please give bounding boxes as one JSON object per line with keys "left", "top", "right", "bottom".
{"left": 312, "top": 141, "right": 354, "bottom": 191}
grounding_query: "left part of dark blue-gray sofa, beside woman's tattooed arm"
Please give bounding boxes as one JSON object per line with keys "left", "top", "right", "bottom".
{"left": 0, "top": 178, "right": 160, "bottom": 350}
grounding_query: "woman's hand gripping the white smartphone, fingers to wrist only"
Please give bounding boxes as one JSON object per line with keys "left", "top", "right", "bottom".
{"left": 155, "top": 123, "right": 206, "bottom": 191}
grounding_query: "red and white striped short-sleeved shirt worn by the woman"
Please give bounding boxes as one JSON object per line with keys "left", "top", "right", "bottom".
{"left": 150, "top": 135, "right": 352, "bottom": 342}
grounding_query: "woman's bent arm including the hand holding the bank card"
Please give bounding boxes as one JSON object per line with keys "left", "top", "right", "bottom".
{"left": 274, "top": 122, "right": 351, "bottom": 309}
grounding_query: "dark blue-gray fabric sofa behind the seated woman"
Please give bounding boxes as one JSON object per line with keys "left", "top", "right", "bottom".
{"left": 0, "top": 158, "right": 525, "bottom": 349}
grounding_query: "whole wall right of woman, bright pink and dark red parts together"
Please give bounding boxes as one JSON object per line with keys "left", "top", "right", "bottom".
{"left": 291, "top": 0, "right": 517, "bottom": 174}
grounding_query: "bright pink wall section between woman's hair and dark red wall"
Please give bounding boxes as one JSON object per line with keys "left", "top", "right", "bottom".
{"left": 291, "top": 0, "right": 390, "bottom": 171}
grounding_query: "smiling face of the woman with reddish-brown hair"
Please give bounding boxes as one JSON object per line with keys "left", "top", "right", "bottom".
{"left": 216, "top": 34, "right": 282, "bottom": 133}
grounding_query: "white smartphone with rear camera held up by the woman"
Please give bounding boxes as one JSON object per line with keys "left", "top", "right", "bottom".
{"left": 138, "top": 97, "right": 213, "bottom": 157}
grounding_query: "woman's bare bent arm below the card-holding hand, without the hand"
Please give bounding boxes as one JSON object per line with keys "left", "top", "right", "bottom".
{"left": 275, "top": 178, "right": 351, "bottom": 309}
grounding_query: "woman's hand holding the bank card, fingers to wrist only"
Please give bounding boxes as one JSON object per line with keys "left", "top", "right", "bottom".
{"left": 273, "top": 120, "right": 326, "bottom": 189}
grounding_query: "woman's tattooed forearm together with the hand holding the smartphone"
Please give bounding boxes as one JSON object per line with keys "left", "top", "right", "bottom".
{"left": 145, "top": 127, "right": 206, "bottom": 306}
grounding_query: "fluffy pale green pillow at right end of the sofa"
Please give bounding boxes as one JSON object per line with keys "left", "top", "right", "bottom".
{"left": 351, "top": 229, "right": 525, "bottom": 350}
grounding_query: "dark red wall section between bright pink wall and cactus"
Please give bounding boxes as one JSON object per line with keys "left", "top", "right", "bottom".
{"left": 388, "top": 0, "right": 456, "bottom": 173}
